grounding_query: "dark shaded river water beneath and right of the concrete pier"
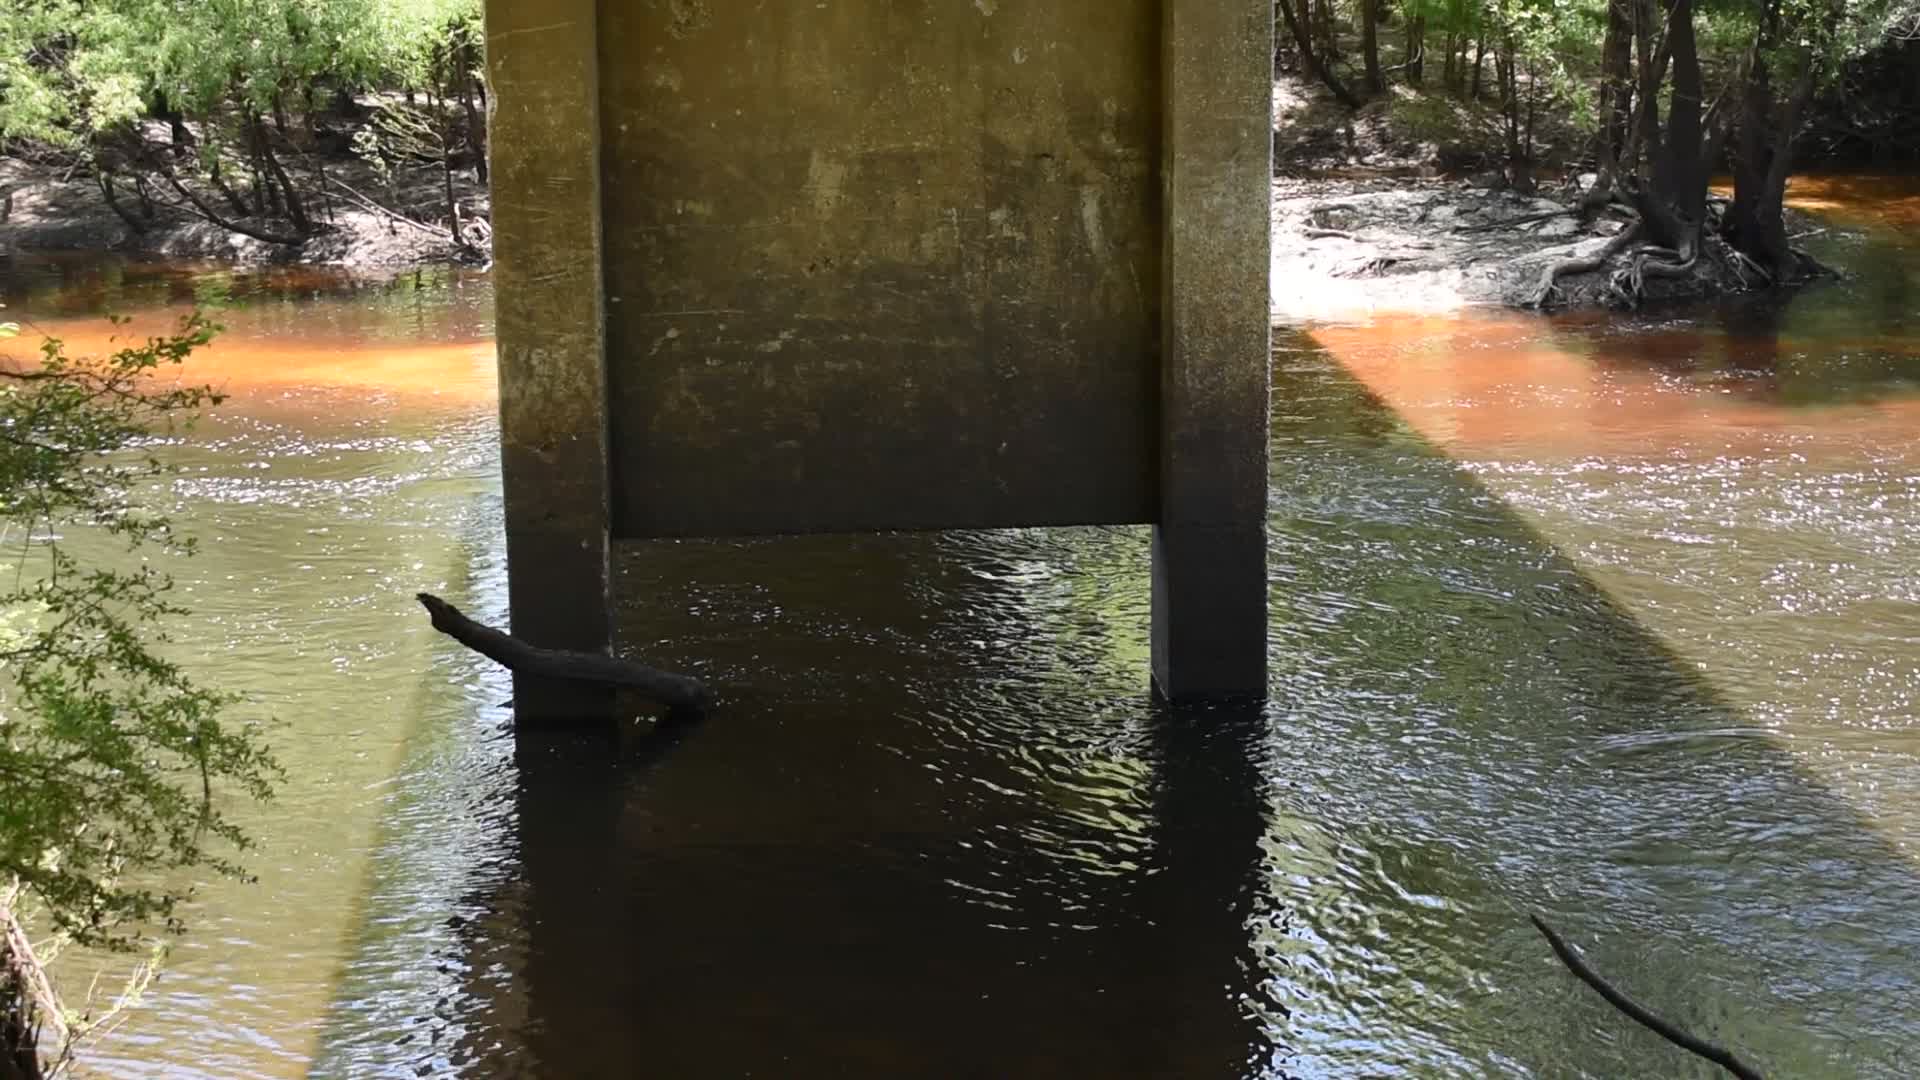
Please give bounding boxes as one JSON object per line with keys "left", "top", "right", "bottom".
{"left": 412, "top": 334, "right": 1920, "bottom": 1076}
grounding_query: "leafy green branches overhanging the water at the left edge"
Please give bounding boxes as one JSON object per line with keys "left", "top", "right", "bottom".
{"left": 0, "top": 315, "right": 276, "bottom": 945}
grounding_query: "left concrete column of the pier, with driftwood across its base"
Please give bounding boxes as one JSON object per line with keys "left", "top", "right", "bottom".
{"left": 486, "top": 0, "right": 612, "bottom": 724}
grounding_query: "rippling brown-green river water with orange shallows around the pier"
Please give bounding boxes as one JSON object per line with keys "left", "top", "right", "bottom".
{"left": 4, "top": 179, "right": 1920, "bottom": 1076}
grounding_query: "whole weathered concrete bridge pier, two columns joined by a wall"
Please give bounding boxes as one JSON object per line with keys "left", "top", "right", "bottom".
{"left": 486, "top": 0, "right": 1273, "bottom": 723}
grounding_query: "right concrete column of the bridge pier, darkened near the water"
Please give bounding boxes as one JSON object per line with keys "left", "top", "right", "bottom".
{"left": 1152, "top": 0, "right": 1273, "bottom": 701}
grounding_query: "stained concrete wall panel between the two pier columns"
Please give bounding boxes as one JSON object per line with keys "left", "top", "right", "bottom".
{"left": 601, "top": 0, "right": 1159, "bottom": 536}
